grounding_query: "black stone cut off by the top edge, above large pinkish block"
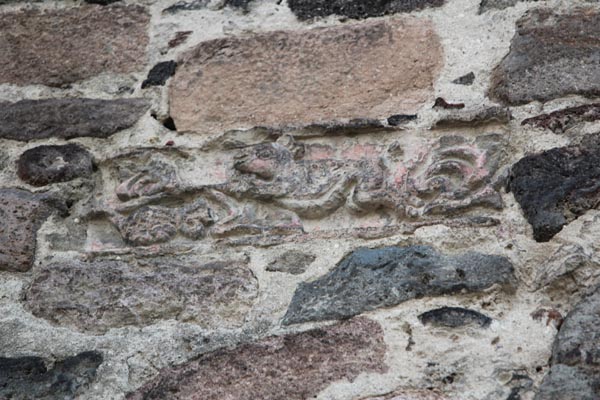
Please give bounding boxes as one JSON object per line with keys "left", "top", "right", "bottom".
{"left": 288, "top": 0, "right": 445, "bottom": 20}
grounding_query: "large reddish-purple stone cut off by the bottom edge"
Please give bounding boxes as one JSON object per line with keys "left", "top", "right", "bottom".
{"left": 127, "top": 318, "right": 387, "bottom": 400}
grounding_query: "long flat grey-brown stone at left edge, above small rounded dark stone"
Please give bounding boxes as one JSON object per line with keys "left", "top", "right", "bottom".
{"left": 0, "top": 98, "right": 149, "bottom": 141}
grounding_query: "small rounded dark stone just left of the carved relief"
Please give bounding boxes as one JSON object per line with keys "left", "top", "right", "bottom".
{"left": 17, "top": 143, "right": 94, "bottom": 186}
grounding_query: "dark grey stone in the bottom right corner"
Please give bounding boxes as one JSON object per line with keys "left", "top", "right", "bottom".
{"left": 535, "top": 288, "right": 600, "bottom": 400}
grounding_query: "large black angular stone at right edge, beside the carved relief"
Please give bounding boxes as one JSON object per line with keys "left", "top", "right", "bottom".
{"left": 509, "top": 143, "right": 600, "bottom": 242}
